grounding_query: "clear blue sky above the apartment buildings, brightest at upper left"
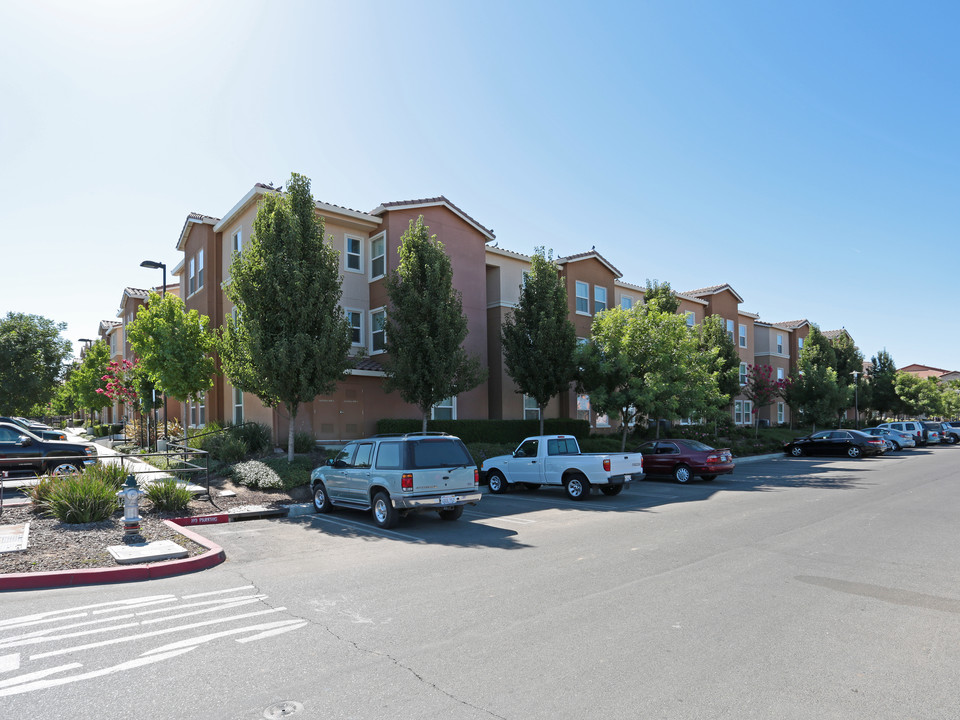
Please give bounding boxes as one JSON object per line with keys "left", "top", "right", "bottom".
{"left": 0, "top": 0, "right": 960, "bottom": 369}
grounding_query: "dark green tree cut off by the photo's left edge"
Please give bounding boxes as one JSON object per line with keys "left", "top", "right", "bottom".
{"left": 0, "top": 312, "right": 70, "bottom": 415}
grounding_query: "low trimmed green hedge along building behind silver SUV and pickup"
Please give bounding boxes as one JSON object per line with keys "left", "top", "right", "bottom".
{"left": 377, "top": 418, "right": 590, "bottom": 446}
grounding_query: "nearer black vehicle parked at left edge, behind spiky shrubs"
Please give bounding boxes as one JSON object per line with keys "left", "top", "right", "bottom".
{"left": 0, "top": 422, "right": 97, "bottom": 475}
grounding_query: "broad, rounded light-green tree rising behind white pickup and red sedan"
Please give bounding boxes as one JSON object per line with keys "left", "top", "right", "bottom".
{"left": 579, "top": 303, "right": 719, "bottom": 449}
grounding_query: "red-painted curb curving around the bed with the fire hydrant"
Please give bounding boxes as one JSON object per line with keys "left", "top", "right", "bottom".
{"left": 0, "top": 520, "right": 227, "bottom": 591}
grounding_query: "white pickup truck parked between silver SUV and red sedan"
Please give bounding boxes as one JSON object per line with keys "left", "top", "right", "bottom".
{"left": 480, "top": 435, "right": 643, "bottom": 500}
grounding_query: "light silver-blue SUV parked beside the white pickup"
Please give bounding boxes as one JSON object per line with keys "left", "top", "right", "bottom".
{"left": 310, "top": 432, "right": 481, "bottom": 528}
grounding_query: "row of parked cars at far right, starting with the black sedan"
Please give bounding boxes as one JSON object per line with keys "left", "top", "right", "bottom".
{"left": 783, "top": 420, "right": 960, "bottom": 458}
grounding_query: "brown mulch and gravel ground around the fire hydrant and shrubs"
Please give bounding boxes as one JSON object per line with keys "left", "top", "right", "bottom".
{"left": 0, "top": 480, "right": 309, "bottom": 574}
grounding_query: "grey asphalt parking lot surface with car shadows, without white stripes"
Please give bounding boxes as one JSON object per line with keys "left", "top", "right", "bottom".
{"left": 5, "top": 447, "right": 960, "bottom": 720}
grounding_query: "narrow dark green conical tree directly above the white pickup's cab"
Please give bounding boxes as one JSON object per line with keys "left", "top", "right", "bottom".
{"left": 502, "top": 247, "right": 577, "bottom": 435}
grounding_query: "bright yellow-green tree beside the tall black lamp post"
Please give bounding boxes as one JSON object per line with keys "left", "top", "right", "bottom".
{"left": 127, "top": 292, "right": 216, "bottom": 414}
